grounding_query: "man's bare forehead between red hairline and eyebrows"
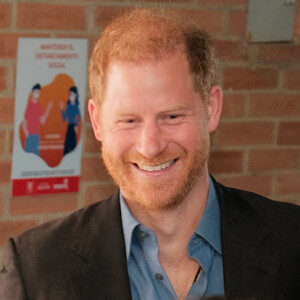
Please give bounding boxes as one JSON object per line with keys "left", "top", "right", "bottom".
{"left": 103, "top": 52, "right": 200, "bottom": 113}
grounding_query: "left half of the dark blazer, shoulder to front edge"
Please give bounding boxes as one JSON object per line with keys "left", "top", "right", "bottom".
{"left": 0, "top": 193, "right": 130, "bottom": 299}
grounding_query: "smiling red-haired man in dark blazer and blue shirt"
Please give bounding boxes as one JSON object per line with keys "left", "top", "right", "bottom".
{"left": 0, "top": 9, "right": 300, "bottom": 300}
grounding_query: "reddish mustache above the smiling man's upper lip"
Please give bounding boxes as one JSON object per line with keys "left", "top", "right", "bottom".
{"left": 123, "top": 148, "right": 187, "bottom": 166}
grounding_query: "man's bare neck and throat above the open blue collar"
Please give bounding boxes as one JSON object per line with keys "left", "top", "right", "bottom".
{"left": 127, "top": 172, "right": 209, "bottom": 260}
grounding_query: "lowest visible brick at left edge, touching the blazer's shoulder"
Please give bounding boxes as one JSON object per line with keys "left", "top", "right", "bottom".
{"left": 0, "top": 220, "right": 38, "bottom": 245}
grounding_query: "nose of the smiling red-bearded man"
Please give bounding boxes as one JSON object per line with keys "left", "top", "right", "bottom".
{"left": 136, "top": 121, "right": 167, "bottom": 158}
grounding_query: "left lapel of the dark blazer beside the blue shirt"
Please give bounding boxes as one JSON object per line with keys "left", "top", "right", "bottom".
{"left": 67, "top": 193, "right": 131, "bottom": 300}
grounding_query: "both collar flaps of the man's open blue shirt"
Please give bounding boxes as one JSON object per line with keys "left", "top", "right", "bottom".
{"left": 120, "top": 178, "right": 222, "bottom": 261}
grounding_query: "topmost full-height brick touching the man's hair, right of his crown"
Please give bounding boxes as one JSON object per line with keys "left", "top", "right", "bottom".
{"left": 182, "top": 9, "right": 223, "bottom": 34}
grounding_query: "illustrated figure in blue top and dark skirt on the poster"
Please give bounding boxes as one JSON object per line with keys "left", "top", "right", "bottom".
{"left": 60, "top": 86, "right": 80, "bottom": 155}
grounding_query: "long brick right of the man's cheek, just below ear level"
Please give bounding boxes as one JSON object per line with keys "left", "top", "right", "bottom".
{"left": 217, "top": 122, "right": 274, "bottom": 146}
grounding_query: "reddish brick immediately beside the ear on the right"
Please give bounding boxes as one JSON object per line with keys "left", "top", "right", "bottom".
{"left": 222, "top": 93, "right": 246, "bottom": 118}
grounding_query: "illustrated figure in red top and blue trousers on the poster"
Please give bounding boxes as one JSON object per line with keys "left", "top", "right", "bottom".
{"left": 22, "top": 83, "right": 53, "bottom": 156}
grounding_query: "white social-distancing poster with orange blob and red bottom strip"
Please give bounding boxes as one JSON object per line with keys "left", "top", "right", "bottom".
{"left": 11, "top": 38, "right": 88, "bottom": 196}
